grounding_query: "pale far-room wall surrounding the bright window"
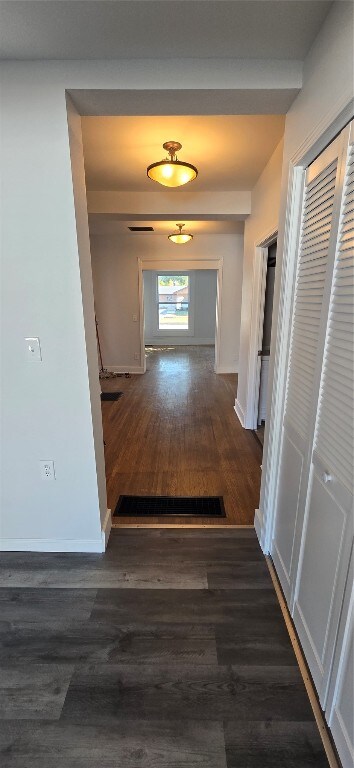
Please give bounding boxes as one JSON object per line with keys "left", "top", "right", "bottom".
{"left": 144, "top": 269, "right": 217, "bottom": 346}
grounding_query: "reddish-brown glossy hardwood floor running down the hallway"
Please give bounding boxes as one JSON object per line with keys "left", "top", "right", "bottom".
{"left": 101, "top": 347, "right": 262, "bottom": 525}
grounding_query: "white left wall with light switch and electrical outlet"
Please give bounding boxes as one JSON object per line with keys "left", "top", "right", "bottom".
{"left": 1, "top": 78, "right": 106, "bottom": 550}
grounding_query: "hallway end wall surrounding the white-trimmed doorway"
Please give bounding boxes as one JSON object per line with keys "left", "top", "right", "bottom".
{"left": 91, "top": 234, "right": 243, "bottom": 372}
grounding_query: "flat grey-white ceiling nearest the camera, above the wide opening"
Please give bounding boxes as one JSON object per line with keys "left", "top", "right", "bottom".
{"left": 0, "top": 0, "right": 331, "bottom": 59}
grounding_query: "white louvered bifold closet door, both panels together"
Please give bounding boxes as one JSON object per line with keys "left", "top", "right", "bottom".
{"left": 271, "top": 124, "right": 354, "bottom": 760}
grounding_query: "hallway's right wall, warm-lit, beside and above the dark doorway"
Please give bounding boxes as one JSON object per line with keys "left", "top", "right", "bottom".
{"left": 237, "top": 141, "right": 283, "bottom": 421}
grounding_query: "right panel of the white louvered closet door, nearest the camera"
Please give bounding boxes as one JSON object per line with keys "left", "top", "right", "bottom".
{"left": 294, "top": 127, "right": 354, "bottom": 704}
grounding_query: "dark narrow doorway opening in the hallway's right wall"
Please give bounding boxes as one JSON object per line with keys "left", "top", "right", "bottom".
{"left": 254, "top": 240, "right": 277, "bottom": 448}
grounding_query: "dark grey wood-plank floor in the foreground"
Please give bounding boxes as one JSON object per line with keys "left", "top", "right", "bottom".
{"left": 0, "top": 529, "right": 328, "bottom": 768}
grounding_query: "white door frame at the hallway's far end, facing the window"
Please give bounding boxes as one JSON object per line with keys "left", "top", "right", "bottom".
{"left": 138, "top": 258, "right": 223, "bottom": 373}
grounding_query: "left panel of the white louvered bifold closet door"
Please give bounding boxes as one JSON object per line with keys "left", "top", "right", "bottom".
{"left": 271, "top": 132, "right": 342, "bottom": 604}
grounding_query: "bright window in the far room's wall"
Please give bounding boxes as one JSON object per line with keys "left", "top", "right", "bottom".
{"left": 157, "top": 274, "right": 191, "bottom": 333}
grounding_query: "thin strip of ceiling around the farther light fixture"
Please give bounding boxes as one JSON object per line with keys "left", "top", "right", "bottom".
{"left": 89, "top": 214, "right": 244, "bottom": 237}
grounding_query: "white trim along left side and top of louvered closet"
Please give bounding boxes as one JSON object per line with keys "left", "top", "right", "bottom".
{"left": 254, "top": 94, "right": 353, "bottom": 555}
